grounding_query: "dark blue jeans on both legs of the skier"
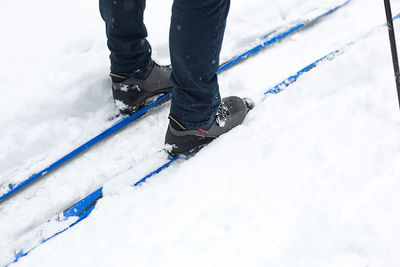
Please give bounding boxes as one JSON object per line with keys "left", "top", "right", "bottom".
{"left": 100, "top": 0, "right": 230, "bottom": 128}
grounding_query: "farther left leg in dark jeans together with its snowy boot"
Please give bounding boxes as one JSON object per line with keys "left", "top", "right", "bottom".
{"left": 100, "top": 0, "right": 172, "bottom": 114}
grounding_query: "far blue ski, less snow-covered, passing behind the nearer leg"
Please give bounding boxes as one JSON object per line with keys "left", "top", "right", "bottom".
{"left": 0, "top": 0, "right": 351, "bottom": 203}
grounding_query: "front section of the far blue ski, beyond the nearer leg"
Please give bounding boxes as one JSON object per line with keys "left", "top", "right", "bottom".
{"left": 217, "top": 0, "right": 350, "bottom": 73}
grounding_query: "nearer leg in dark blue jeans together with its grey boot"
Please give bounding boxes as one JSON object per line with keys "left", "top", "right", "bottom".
{"left": 165, "top": 0, "right": 254, "bottom": 157}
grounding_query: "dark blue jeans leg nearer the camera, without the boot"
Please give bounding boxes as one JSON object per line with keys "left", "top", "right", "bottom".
{"left": 170, "top": 0, "right": 230, "bottom": 129}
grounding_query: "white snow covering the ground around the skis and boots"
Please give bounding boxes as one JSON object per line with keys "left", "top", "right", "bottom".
{"left": 0, "top": 0, "right": 400, "bottom": 267}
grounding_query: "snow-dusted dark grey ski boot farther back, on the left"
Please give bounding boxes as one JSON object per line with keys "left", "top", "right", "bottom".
{"left": 110, "top": 63, "right": 172, "bottom": 115}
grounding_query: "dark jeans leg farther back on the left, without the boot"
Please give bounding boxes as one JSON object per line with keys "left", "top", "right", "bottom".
{"left": 99, "top": 0, "right": 153, "bottom": 78}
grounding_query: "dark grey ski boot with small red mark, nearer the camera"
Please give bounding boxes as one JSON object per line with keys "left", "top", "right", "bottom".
{"left": 165, "top": 96, "right": 255, "bottom": 157}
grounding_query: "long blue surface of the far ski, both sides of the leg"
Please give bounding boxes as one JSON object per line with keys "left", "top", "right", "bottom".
{"left": 0, "top": 0, "right": 350, "bottom": 202}
